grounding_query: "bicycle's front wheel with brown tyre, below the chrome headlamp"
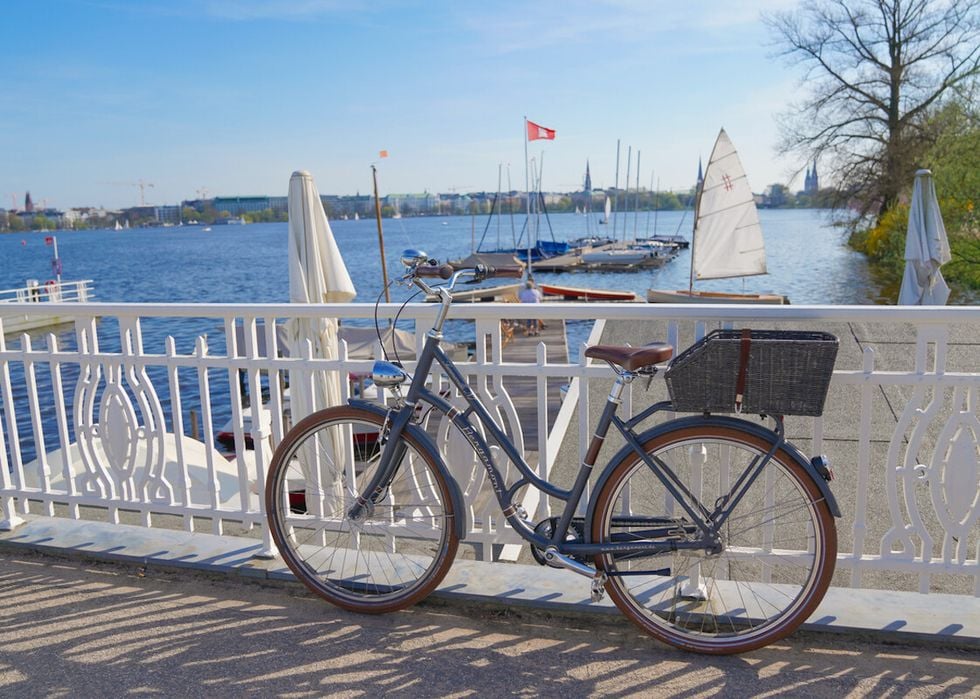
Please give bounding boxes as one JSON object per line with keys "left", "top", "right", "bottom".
{"left": 265, "top": 406, "right": 459, "bottom": 613}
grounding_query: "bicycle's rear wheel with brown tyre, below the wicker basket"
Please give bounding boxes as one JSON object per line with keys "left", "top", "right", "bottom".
{"left": 592, "top": 425, "right": 837, "bottom": 654}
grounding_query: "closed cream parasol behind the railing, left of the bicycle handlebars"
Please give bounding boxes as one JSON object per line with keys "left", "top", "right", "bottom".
{"left": 288, "top": 170, "right": 357, "bottom": 424}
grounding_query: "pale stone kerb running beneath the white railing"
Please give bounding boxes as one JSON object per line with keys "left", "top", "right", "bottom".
{"left": 0, "top": 516, "right": 980, "bottom": 650}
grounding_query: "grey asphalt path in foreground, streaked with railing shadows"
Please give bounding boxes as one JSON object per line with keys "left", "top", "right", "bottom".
{"left": 0, "top": 548, "right": 980, "bottom": 699}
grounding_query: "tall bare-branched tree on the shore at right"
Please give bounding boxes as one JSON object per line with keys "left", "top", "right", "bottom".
{"left": 763, "top": 0, "right": 980, "bottom": 215}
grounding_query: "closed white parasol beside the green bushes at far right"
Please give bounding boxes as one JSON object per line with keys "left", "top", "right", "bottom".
{"left": 898, "top": 170, "right": 950, "bottom": 306}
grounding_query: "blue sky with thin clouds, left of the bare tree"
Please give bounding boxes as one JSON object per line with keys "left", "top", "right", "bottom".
{"left": 0, "top": 0, "right": 805, "bottom": 209}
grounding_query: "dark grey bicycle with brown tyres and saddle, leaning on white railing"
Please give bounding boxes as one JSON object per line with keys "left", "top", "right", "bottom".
{"left": 265, "top": 250, "right": 840, "bottom": 654}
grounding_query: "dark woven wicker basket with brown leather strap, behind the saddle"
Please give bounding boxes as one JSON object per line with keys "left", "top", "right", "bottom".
{"left": 664, "top": 330, "right": 838, "bottom": 416}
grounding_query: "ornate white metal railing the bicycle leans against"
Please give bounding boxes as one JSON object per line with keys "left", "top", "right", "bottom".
{"left": 0, "top": 303, "right": 980, "bottom": 596}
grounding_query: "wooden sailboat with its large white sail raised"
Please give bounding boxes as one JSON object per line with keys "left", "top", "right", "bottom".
{"left": 647, "top": 129, "right": 789, "bottom": 304}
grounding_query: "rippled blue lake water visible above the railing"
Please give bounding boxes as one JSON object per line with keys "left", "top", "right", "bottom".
{"left": 0, "top": 210, "right": 878, "bottom": 304}
